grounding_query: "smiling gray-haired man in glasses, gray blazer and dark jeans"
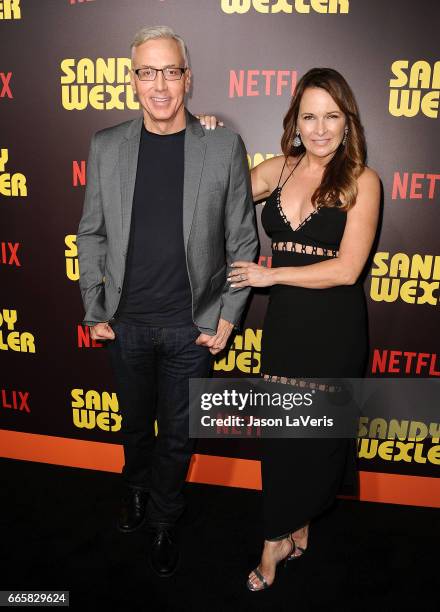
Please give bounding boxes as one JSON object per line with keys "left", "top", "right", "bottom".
{"left": 77, "top": 26, "right": 257, "bottom": 576}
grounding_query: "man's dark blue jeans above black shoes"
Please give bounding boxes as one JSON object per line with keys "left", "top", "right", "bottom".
{"left": 107, "top": 321, "right": 212, "bottom": 526}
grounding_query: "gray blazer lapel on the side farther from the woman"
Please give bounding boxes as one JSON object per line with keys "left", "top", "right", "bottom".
{"left": 119, "top": 117, "right": 143, "bottom": 249}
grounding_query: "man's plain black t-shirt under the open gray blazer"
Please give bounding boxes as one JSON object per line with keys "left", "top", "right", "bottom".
{"left": 116, "top": 122, "right": 192, "bottom": 327}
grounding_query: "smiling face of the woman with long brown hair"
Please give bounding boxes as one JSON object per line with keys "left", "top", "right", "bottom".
{"left": 297, "top": 87, "right": 346, "bottom": 158}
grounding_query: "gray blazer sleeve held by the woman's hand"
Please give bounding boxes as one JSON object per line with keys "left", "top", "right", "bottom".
{"left": 220, "top": 134, "right": 258, "bottom": 327}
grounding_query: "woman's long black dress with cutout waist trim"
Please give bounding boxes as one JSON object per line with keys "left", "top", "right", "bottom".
{"left": 261, "top": 159, "right": 367, "bottom": 540}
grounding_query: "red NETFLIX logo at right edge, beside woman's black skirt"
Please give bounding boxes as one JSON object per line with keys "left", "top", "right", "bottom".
{"left": 371, "top": 349, "right": 440, "bottom": 377}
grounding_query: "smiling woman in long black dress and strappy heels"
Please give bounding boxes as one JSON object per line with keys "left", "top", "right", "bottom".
{"left": 199, "top": 68, "right": 380, "bottom": 591}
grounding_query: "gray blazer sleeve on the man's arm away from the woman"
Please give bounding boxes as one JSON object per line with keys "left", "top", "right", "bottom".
{"left": 76, "top": 134, "right": 107, "bottom": 325}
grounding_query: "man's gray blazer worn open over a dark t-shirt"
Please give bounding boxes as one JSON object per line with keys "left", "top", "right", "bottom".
{"left": 77, "top": 111, "right": 258, "bottom": 335}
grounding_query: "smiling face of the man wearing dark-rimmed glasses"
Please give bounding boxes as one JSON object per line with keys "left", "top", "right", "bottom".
{"left": 131, "top": 38, "right": 191, "bottom": 128}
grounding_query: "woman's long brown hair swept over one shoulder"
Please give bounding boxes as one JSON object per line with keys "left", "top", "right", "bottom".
{"left": 281, "top": 68, "right": 367, "bottom": 210}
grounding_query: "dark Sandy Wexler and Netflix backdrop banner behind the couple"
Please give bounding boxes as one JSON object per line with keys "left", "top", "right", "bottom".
{"left": 0, "top": 0, "right": 440, "bottom": 506}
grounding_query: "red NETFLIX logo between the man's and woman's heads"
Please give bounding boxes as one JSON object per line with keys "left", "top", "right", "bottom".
{"left": 229, "top": 70, "right": 298, "bottom": 98}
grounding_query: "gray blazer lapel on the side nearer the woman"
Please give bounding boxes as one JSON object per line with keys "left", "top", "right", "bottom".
{"left": 183, "top": 111, "right": 206, "bottom": 251}
